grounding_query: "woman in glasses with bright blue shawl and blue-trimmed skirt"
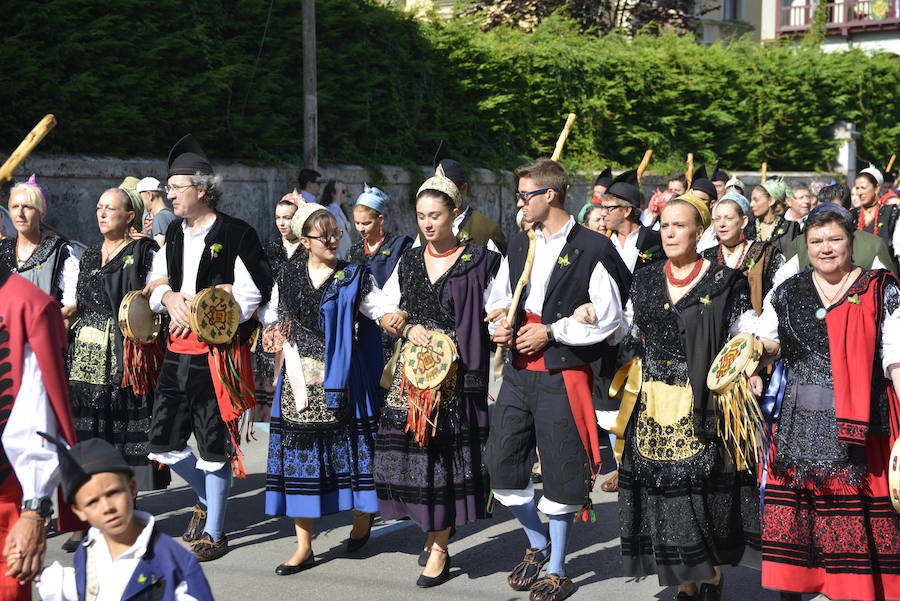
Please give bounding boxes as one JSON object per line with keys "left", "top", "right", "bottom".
{"left": 259, "top": 202, "right": 400, "bottom": 576}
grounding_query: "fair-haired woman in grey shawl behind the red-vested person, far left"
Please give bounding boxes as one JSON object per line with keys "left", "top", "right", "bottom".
{"left": 0, "top": 175, "right": 78, "bottom": 318}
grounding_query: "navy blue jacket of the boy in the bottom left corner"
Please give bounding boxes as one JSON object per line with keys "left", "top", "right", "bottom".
{"left": 74, "top": 526, "right": 213, "bottom": 601}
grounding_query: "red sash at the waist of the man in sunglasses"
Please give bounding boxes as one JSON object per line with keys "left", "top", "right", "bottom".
{"left": 513, "top": 312, "right": 600, "bottom": 478}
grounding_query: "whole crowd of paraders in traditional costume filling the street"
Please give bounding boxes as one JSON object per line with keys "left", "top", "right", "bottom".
{"left": 0, "top": 135, "right": 900, "bottom": 601}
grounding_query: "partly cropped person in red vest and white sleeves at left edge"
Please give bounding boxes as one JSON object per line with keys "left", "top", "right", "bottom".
{"left": 0, "top": 273, "right": 77, "bottom": 601}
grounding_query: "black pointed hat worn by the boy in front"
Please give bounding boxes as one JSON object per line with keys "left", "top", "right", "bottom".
{"left": 38, "top": 432, "right": 134, "bottom": 504}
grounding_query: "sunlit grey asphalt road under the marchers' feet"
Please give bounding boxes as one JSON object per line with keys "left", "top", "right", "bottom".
{"left": 42, "top": 429, "right": 825, "bottom": 601}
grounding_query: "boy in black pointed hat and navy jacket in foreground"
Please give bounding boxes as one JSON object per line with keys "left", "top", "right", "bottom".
{"left": 38, "top": 434, "right": 213, "bottom": 601}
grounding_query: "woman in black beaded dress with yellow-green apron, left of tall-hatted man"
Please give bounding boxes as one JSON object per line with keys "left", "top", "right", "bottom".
{"left": 63, "top": 188, "right": 170, "bottom": 552}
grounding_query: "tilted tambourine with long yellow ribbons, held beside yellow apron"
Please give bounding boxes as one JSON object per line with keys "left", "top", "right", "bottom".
{"left": 706, "top": 334, "right": 765, "bottom": 470}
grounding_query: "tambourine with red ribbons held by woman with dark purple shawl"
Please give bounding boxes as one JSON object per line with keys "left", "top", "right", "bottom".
{"left": 400, "top": 330, "right": 458, "bottom": 447}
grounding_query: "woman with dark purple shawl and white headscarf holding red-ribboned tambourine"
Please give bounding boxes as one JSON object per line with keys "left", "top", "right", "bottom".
{"left": 375, "top": 176, "right": 500, "bottom": 588}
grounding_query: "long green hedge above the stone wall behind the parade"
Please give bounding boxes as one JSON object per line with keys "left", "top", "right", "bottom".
{"left": 0, "top": 0, "right": 900, "bottom": 176}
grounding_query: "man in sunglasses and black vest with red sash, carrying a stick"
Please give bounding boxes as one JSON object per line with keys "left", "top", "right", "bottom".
{"left": 485, "top": 159, "right": 631, "bottom": 601}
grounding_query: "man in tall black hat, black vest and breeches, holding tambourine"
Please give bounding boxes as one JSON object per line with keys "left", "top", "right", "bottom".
{"left": 147, "top": 134, "right": 272, "bottom": 561}
